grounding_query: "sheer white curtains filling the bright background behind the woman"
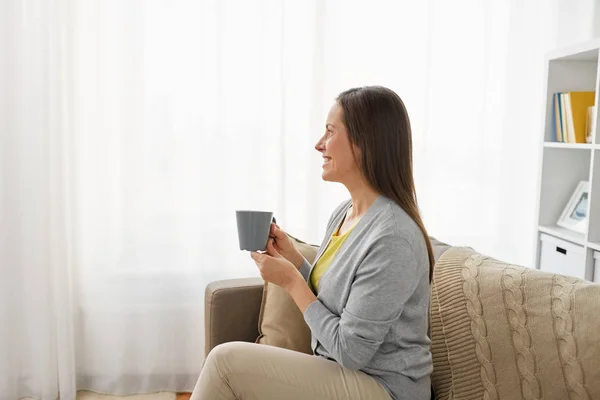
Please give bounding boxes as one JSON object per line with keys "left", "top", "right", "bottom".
{"left": 0, "top": 0, "right": 598, "bottom": 400}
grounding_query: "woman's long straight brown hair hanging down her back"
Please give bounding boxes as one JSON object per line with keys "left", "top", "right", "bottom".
{"left": 336, "top": 86, "right": 435, "bottom": 282}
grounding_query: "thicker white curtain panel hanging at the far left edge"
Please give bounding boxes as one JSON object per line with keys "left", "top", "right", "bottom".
{"left": 0, "top": 1, "right": 78, "bottom": 400}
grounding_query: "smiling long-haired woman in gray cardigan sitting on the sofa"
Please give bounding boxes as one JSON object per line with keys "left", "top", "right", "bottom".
{"left": 192, "top": 86, "right": 433, "bottom": 400}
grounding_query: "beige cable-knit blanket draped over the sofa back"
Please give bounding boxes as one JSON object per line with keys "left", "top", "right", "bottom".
{"left": 431, "top": 247, "right": 600, "bottom": 399}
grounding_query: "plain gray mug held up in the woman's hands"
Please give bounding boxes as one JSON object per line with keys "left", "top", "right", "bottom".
{"left": 235, "top": 210, "right": 275, "bottom": 251}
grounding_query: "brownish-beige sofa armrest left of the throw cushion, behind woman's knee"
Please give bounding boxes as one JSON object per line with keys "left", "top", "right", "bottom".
{"left": 204, "top": 278, "right": 264, "bottom": 355}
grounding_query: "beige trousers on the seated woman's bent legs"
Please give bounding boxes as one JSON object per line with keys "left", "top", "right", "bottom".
{"left": 190, "top": 342, "right": 391, "bottom": 400}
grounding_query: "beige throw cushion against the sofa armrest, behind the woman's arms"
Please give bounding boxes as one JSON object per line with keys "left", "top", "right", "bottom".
{"left": 256, "top": 235, "right": 319, "bottom": 354}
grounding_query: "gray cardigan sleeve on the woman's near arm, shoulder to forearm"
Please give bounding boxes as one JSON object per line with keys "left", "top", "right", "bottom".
{"left": 304, "top": 233, "right": 424, "bottom": 370}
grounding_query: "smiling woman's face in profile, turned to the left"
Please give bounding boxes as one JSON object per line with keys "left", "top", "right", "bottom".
{"left": 315, "top": 103, "right": 360, "bottom": 183}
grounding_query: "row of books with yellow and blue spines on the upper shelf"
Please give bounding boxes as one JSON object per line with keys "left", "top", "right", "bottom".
{"left": 552, "top": 92, "right": 596, "bottom": 143}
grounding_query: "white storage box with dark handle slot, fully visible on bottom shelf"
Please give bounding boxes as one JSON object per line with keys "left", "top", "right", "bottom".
{"left": 540, "top": 233, "right": 584, "bottom": 279}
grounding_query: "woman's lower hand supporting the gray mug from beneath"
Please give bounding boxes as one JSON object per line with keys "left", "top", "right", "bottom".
{"left": 250, "top": 238, "right": 306, "bottom": 290}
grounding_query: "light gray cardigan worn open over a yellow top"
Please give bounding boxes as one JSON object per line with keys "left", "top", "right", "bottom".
{"left": 300, "top": 195, "right": 433, "bottom": 399}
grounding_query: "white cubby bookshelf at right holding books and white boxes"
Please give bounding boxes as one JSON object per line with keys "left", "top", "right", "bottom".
{"left": 535, "top": 39, "right": 600, "bottom": 282}
